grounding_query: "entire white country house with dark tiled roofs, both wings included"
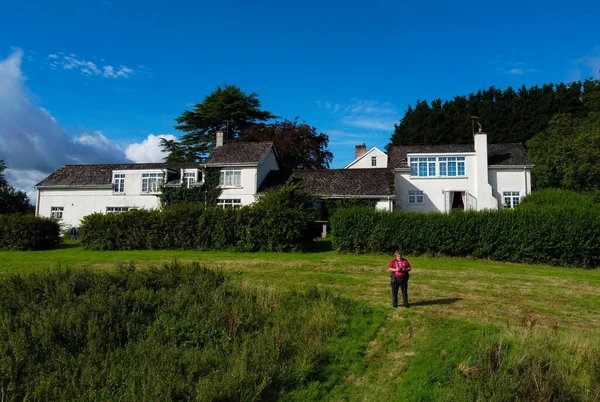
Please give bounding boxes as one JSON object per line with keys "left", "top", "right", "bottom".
{"left": 36, "top": 133, "right": 532, "bottom": 226}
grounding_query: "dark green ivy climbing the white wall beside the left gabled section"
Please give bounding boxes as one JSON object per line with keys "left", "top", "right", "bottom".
{"left": 158, "top": 167, "right": 222, "bottom": 208}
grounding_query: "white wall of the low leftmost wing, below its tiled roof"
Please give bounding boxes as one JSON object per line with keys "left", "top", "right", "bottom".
{"left": 38, "top": 188, "right": 159, "bottom": 226}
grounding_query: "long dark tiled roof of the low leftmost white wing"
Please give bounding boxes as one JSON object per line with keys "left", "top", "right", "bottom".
{"left": 36, "top": 162, "right": 200, "bottom": 187}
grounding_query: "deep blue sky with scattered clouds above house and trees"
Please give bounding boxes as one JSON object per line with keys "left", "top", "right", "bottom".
{"left": 0, "top": 0, "right": 600, "bottom": 195}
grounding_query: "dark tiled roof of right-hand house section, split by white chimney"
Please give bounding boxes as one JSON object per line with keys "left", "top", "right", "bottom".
{"left": 388, "top": 143, "right": 532, "bottom": 169}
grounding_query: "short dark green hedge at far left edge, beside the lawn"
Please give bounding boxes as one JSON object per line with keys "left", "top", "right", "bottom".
{"left": 0, "top": 214, "right": 60, "bottom": 250}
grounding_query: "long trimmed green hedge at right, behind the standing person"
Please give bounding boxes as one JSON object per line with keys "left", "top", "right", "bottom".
{"left": 332, "top": 208, "right": 600, "bottom": 267}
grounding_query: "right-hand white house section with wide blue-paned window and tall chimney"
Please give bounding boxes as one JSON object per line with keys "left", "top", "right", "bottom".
{"left": 388, "top": 132, "right": 533, "bottom": 212}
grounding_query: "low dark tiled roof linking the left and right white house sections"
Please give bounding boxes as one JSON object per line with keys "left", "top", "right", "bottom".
{"left": 292, "top": 168, "right": 394, "bottom": 196}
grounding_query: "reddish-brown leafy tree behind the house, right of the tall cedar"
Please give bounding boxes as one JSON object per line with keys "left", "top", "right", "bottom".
{"left": 240, "top": 118, "right": 333, "bottom": 171}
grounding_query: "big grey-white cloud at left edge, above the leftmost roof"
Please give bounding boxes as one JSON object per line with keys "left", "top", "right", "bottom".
{"left": 0, "top": 49, "right": 127, "bottom": 198}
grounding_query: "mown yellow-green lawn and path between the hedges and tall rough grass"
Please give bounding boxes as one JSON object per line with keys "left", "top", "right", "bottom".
{"left": 0, "top": 243, "right": 600, "bottom": 400}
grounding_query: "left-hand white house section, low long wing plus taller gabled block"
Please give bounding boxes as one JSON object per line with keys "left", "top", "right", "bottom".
{"left": 36, "top": 137, "right": 279, "bottom": 226}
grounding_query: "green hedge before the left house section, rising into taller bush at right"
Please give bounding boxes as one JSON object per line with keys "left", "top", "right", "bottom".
{"left": 80, "top": 182, "right": 314, "bottom": 251}
